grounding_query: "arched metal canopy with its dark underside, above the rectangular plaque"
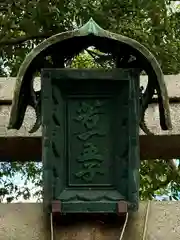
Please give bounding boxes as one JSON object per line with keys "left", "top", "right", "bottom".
{"left": 8, "top": 18, "right": 172, "bottom": 132}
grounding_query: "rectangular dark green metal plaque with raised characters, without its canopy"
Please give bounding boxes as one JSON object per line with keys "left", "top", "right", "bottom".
{"left": 41, "top": 69, "right": 140, "bottom": 213}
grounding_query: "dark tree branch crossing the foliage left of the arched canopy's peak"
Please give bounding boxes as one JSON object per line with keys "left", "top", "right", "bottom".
{"left": 0, "top": 32, "right": 53, "bottom": 47}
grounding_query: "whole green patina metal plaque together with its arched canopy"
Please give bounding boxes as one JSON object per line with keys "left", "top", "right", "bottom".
{"left": 9, "top": 18, "right": 172, "bottom": 213}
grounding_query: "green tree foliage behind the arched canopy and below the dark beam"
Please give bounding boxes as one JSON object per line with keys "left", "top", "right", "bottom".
{"left": 0, "top": 0, "right": 180, "bottom": 200}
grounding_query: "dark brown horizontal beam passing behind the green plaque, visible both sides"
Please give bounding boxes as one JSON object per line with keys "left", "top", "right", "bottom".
{"left": 0, "top": 135, "right": 180, "bottom": 162}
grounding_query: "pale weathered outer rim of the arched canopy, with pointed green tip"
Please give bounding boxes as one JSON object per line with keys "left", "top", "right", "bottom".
{"left": 8, "top": 18, "right": 172, "bottom": 129}
